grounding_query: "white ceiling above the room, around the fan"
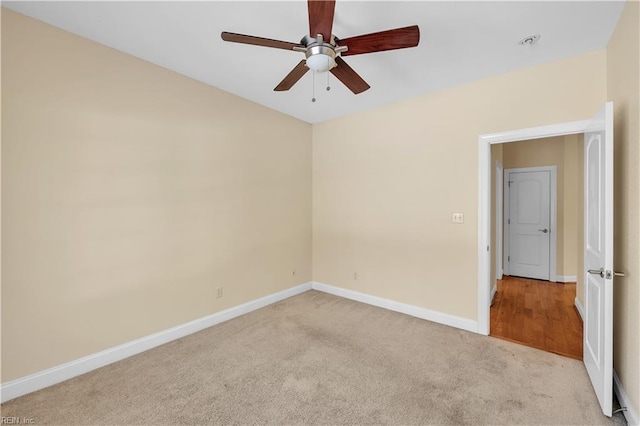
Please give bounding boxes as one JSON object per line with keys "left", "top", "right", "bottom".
{"left": 2, "top": 0, "right": 624, "bottom": 123}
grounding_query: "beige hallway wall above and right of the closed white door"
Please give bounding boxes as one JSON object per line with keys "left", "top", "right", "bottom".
{"left": 503, "top": 135, "right": 583, "bottom": 276}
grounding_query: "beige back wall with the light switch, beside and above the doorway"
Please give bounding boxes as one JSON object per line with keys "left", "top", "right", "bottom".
{"left": 312, "top": 51, "right": 606, "bottom": 320}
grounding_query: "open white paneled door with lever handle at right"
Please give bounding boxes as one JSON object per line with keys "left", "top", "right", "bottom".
{"left": 584, "top": 102, "right": 613, "bottom": 416}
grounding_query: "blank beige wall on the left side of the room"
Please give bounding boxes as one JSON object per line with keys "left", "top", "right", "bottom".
{"left": 2, "top": 10, "right": 311, "bottom": 382}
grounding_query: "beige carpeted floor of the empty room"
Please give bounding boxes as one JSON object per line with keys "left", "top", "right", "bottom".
{"left": 2, "top": 291, "right": 623, "bottom": 425}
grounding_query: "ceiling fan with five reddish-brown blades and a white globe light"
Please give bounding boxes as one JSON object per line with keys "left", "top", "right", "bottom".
{"left": 221, "top": 0, "right": 420, "bottom": 94}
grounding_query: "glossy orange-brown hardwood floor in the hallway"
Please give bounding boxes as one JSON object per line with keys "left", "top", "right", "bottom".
{"left": 490, "top": 276, "right": 582, "bottom": 360}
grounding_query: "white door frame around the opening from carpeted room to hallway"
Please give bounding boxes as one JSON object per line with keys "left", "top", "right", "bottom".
{"left": 478, "top": 120, "right": 590, "bottom": 335}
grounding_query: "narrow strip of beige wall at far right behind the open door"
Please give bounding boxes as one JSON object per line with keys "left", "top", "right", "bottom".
{"left": 607, "top": 1, "right": 640, "bottom": 413}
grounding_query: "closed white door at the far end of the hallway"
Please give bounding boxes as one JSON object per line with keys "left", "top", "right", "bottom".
{"left": 505, "top": 169, "right": 552, "bottom": 280}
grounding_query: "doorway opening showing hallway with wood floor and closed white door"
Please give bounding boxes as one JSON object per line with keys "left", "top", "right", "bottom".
{"left": 490, "top": 135, "right": 583, "bottom": 359}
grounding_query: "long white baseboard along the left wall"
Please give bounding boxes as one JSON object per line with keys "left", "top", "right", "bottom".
{"left": 0, "top": 282, "right": 311, "bottom": 402}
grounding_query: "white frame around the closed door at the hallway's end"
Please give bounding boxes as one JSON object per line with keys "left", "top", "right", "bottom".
{"left": 503, "top": 166, "right": 558, "bottom": 283}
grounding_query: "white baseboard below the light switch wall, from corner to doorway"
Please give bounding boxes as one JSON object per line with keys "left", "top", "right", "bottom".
{"left": 311, "top": 281, "right": 478, "bottom": 333}
